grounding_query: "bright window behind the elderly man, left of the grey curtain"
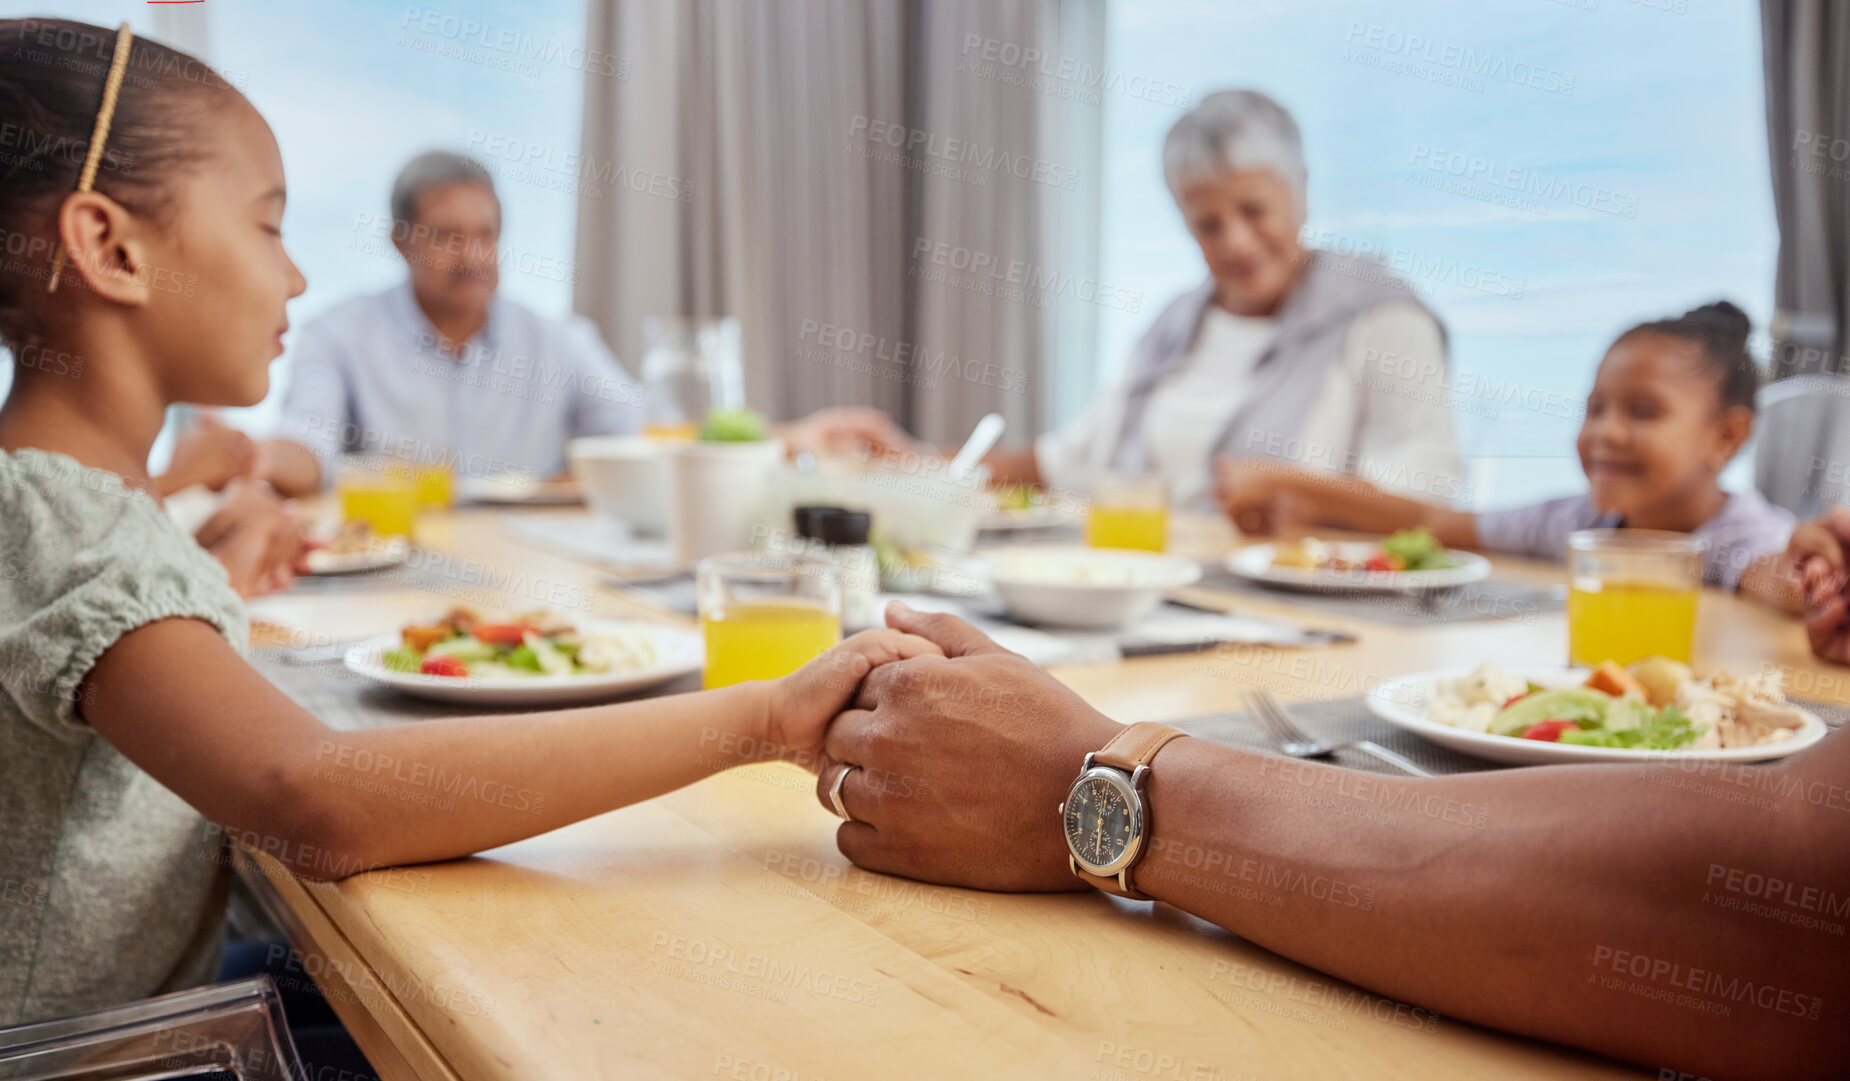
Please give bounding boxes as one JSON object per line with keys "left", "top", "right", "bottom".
{"left": 0, "top": 0, "right": 584, "bottom": 444}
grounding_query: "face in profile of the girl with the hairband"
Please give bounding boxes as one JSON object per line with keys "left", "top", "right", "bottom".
{"left": 139, "top": 102, "right": 307, "bottom": 405}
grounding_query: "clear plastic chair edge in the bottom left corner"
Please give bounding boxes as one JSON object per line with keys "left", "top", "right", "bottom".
{"left": 0, "top": 975, "right": 303, "bottom": 1081}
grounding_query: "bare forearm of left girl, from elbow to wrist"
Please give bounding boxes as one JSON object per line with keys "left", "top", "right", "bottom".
{"left": 277, "top": 683, "right": 775, "bottom": 877}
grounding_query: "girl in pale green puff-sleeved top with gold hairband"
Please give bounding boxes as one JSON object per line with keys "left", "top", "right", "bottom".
{"left": 0, "top": 19, "right": 938, "bottom": 1025}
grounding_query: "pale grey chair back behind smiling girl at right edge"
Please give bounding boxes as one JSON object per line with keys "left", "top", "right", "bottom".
{"left": 1754, "top": 372, "right": 1850, "bottom": 518}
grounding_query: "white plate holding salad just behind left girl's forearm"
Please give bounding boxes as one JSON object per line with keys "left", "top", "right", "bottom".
{"left": 346, "top": 620, "right": 707, "bottom": 707}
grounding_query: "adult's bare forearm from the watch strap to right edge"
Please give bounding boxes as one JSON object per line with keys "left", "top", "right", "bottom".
{"left": 1136, "top": 740, "right": 1850, "bottom": 1077}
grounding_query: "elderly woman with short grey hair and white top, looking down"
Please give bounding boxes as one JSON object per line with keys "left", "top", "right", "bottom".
{"left": 990, "top": 91, "right": 1462, "bottom": 509}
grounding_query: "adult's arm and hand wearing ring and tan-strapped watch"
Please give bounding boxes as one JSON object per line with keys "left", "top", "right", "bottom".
{"left": 818, "top": 607, "right": 1850, "bottom": 1081}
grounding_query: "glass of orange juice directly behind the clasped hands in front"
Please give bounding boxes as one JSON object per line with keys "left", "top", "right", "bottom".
{"left": 696, "top": 552, "right": 842, "bottom": 687}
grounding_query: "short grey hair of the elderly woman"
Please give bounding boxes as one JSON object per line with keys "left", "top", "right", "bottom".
{"left": 1162, "top": 91, "right": 1310, "bottom": 209}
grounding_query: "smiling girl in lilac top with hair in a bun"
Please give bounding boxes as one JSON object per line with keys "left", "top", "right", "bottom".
{"left": 1219, "top": 300, "right": 1800, "bottom": 609}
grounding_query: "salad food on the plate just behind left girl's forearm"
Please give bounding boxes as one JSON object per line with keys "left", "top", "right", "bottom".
{"left": 381, "top": 607, "right": 660, "bottom": 677}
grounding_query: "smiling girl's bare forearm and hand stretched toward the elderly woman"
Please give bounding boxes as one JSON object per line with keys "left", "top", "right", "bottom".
{"left": 1215, "top": 457, "right": 1478, "bottom": 548}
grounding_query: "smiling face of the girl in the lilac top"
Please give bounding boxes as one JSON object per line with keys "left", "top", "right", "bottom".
{"left": 1576, "top": 333, "right": 1754, "bottom": 516}
